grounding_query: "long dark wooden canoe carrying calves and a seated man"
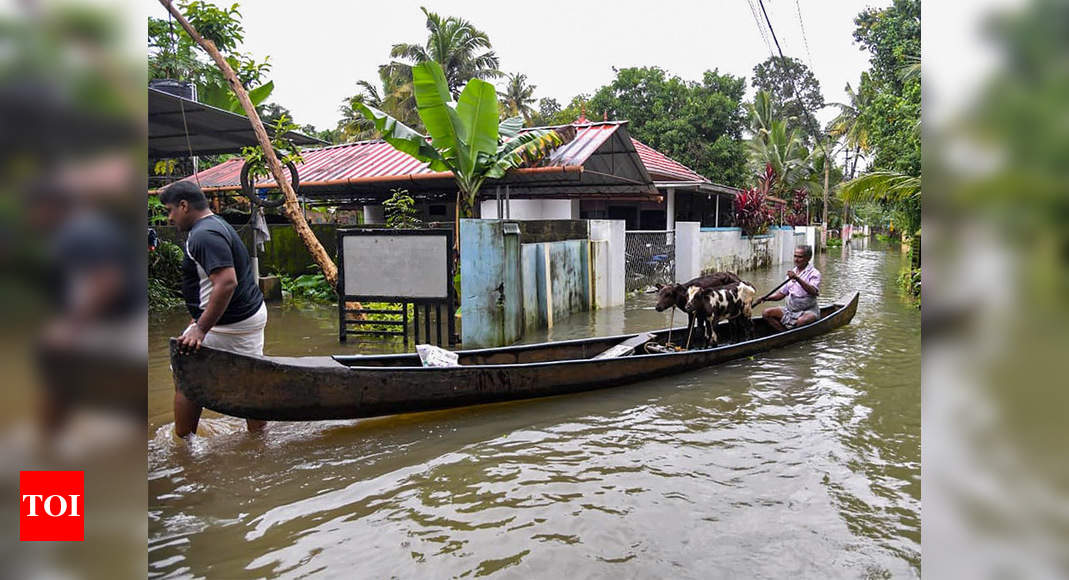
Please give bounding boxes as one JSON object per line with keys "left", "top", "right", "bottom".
{"left": 171, "top": 293, "right": 858, "bottom": 421}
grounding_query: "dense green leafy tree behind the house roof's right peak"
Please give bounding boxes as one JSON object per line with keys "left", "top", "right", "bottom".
{"left": 585, "top": 67, "right": 748, "bottom": 185}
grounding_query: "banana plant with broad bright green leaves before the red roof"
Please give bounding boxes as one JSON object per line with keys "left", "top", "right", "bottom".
{"left": 354, "top": 61, "right": 575, "bottom": 233}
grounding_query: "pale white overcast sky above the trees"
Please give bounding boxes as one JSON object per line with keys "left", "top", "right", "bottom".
{"left": 149, "top": 0, "right": 890, "bottom": 129}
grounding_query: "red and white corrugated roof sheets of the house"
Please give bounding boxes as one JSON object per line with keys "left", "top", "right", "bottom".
{"left": 175, "top": 122, "right": 709, "bottom": 190}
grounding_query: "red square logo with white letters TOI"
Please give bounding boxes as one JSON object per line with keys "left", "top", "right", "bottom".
{"left": 18, "top": 471, "right": 86, "bottom": 542}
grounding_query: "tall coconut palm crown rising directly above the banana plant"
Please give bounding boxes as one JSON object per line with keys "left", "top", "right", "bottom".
{"left": 388, "top": 6, "right": 501, "bottom": 99}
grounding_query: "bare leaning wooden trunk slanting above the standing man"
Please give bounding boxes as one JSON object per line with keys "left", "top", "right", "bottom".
{"left": 159, "top": 0, "right": 341, "bottom": 288}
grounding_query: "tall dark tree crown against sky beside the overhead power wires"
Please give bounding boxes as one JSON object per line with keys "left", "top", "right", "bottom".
{"left": 754, "top": 57, "right": 824, "bottom": 145}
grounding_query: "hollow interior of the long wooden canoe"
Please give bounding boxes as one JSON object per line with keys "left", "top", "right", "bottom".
{"left": 332, "top": 304, "right": 841, "bottom": 366}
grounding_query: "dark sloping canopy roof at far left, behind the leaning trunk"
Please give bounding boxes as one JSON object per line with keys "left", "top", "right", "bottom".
{"left": 149, "top": 87, "right": 325, "bottom": 158}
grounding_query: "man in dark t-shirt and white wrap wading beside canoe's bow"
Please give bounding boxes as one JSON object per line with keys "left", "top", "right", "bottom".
{"left": 159, "top": 182, "right": 267, "bottom": 437}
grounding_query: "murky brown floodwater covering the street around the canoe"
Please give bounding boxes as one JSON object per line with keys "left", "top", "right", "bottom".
{"left": 149, "top": 240, "right": 920, "bottom": 578}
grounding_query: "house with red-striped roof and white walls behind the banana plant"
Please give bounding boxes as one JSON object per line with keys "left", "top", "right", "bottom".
{"left": 177, "top": 120, "right": 737, "bottom": 230}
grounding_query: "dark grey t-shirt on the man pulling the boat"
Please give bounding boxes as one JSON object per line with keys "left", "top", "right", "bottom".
{"left": 182, "top": 214, "right": 264, "bottom": 325}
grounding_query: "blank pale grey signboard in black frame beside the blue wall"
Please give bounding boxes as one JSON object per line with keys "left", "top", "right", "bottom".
{"left": 342, "top": 234, "right": 452, "bottom": 299}
